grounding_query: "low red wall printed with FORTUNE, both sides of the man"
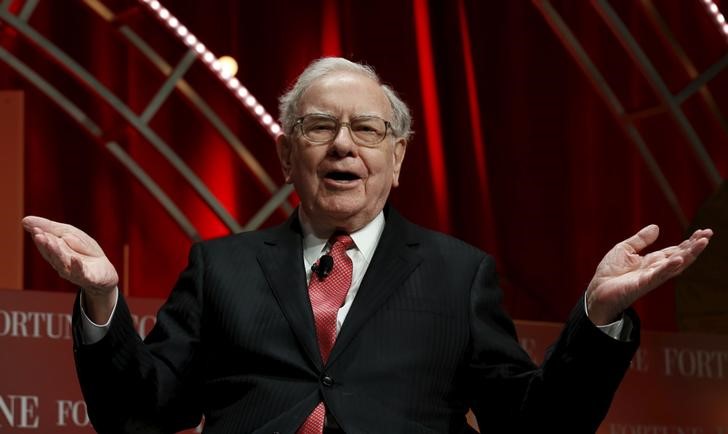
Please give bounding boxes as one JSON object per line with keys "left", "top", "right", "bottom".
{"left": 0, "top": 291, "right": 728, "bottom": 434}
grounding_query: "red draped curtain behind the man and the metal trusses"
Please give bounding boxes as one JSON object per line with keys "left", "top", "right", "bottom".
{"left": 0, "top": 0, "right": 728, "bottom": 330}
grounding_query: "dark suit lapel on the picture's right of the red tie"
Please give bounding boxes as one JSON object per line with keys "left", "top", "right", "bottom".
{"left": 327, "top": 207, "right": 422, "bottom": 365}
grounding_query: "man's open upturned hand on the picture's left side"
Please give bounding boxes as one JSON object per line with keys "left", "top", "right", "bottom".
{"left": 23, "top": 216, "right": 119, "bottom": 324}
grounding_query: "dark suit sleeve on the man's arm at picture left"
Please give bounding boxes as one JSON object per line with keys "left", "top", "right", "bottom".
{"left": 73, "top": 244, "right": 204, "bottom": 433}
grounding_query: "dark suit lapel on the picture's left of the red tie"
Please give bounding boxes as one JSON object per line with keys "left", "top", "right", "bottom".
{"left": 258, "top": 215, "right": 323, "bottom": 367}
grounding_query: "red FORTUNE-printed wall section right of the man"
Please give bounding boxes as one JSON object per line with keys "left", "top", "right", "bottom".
{"left": 516, "top": 321, "right": 728, "bottom": 434}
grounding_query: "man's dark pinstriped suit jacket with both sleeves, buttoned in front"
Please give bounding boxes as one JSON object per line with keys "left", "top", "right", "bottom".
{"left": 74, "top": 208, "right": 638, "bottom": 434}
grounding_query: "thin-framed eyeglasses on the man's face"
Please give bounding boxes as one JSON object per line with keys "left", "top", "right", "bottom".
{"left": 293, "top": 113, "right": 392, "bottom": 148}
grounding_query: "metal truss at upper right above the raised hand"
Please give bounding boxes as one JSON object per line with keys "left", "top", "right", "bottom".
{"left": 533, "top": 0, "right": 728, "bottom": 227}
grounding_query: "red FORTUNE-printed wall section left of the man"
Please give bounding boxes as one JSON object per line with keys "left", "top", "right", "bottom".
{"left": 0, "top": 291, "right": 161, "bottom": 434}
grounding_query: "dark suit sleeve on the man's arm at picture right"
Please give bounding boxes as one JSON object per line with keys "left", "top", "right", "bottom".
{"left": 468, "top": 257, "right": 639, "bottom": 434}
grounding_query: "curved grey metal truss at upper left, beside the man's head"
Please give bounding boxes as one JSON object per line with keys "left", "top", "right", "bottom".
{"left": 0, "top": 0, "right": 292, "bottom": 240}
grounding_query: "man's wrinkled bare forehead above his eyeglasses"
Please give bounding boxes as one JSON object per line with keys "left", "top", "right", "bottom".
{"left": 298, "top": 71, "right": 392, "bottom": 121}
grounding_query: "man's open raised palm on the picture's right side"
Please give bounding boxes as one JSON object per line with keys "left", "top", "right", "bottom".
{"left": 586, "top": 225, "right": 713, "bottom": 325}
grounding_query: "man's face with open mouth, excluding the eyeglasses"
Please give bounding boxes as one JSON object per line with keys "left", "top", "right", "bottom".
{"left": 277, "top": 71, "right": 406, "bottom": 236}
